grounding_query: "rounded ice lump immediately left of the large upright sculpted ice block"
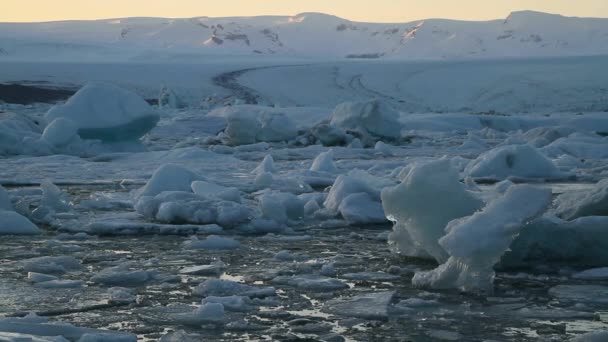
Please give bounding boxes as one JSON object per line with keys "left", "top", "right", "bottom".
{"left": 338, "top": 192, "right": 388, "bottom": 224}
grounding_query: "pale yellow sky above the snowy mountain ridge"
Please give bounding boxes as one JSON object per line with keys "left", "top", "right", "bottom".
{"left": 0, "top": 0, "right": 608, "bottom": 22}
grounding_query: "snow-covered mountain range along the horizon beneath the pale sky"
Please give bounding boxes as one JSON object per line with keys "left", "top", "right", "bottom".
{"left": 0, "top": 11, "right": 608, "bottom": 60}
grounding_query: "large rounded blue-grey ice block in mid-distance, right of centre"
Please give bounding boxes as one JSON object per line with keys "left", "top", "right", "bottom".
{"left": 331, "top": 100, "right": 401, "bottom": 139}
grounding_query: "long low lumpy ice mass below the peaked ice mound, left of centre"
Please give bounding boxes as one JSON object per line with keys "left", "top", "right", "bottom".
{"left": 135, "top": 192, "right": 251, "bottom": 227}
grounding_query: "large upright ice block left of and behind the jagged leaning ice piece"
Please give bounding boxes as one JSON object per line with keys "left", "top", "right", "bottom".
{"left": 382, "top": 159, "right": 483, "bottom": 262}
